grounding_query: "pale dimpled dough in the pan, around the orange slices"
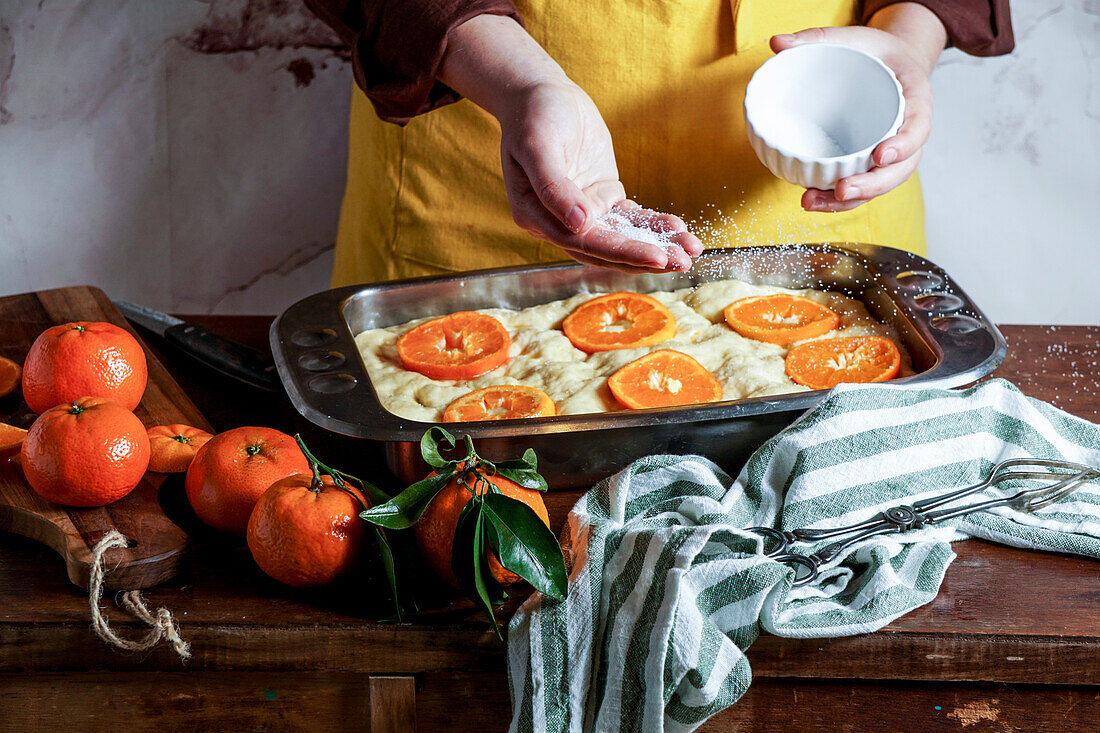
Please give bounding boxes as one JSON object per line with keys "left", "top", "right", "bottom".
{"left": 355, "top": 280, "right": 912, "bottom": 423}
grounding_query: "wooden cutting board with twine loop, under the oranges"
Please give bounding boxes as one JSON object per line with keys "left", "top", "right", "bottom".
{"left": 0, "top": 286, "right": 210, "bottom": 590}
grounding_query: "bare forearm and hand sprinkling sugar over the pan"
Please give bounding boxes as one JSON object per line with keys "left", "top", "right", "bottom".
{"left": 439, "top": 14, "right": 703, "bottom": 272}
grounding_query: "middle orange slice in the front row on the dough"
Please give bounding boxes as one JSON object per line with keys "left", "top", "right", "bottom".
{"left": 607, "top": 349, "right": 722, "bottom": 409}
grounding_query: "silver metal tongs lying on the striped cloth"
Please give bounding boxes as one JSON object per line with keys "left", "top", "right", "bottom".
{"left": 748, "top": 458, "right": 1100, "bottom": 586}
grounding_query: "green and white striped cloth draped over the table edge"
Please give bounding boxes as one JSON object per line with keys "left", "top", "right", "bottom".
{"left": 508, "top": 381, "right": 1100, "bottom": 732}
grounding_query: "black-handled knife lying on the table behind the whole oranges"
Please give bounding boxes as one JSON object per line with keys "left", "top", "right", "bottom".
{"left": 114, "top": 300, "right": 283, "bottom": 392}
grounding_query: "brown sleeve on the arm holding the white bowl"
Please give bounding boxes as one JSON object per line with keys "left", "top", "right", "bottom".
{"left": 862, "top": 0, "right": 1015, "bottom": 56}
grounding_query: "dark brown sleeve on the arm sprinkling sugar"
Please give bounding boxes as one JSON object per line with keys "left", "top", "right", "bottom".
{"left": 306, "top": 0, "right": 523, "bottom": 124}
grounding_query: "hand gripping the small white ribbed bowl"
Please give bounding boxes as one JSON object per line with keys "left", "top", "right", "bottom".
{"left": 771, "top": 3, "right": 946, "bottom": 211}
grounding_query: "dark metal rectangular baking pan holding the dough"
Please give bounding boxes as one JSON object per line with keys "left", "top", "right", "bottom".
{"left": 271, "top": 244, "right": 1007, "bottom": 489}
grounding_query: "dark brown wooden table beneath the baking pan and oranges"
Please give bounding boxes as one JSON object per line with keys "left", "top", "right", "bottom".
{"left": 0, "top": 317, "right": 1100, "bottom": 733}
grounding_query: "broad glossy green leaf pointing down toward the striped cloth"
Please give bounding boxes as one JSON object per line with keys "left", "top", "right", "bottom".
{"left": 482, "top": 493, "right": 569, "bottom": 601}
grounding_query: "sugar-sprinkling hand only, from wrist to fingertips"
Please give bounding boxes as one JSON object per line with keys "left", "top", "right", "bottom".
{"left": 498, "top": 83, "right": 703, "bottom": 272}
